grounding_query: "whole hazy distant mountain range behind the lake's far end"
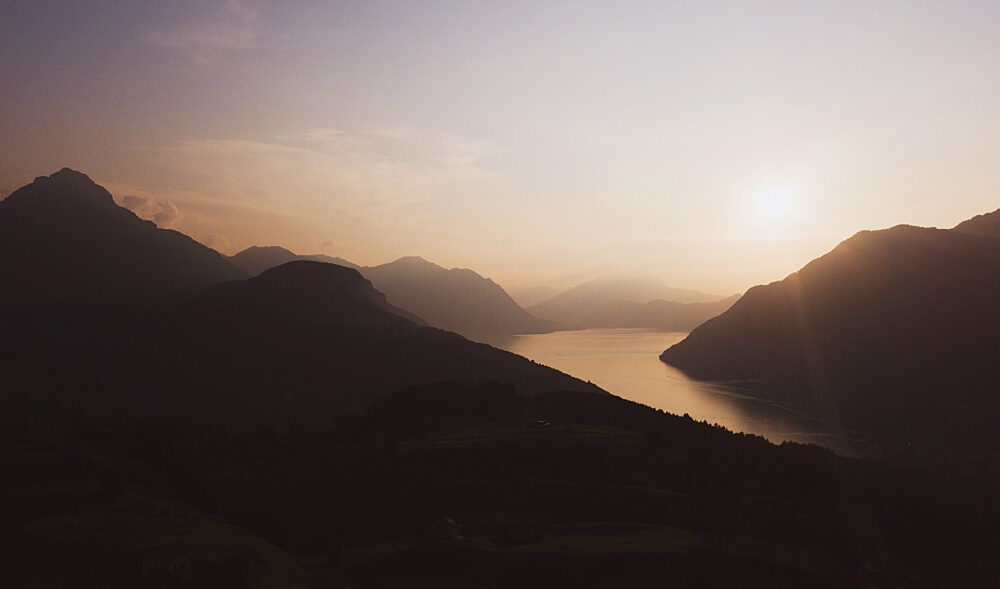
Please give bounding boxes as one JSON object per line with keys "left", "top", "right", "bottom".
{"left": 229, "top": 246, "right": 738, "bottom": 341}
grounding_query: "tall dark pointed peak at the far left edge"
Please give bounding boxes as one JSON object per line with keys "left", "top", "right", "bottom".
{"left": 0, "top": 168, "right": 244, "bottom": 304}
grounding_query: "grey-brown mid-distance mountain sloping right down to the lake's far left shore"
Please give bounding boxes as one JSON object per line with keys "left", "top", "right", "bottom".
{"left": 361, "top": 257, "right": 552, "bottom": 339}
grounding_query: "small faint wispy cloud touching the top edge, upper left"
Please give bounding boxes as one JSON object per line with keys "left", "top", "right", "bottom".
{"left": 141, "top": 0, "right": 260, "bottom": 63}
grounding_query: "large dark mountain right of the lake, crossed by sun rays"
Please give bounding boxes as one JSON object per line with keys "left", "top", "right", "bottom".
{"left": 661, "top": 222, "right": 1000, "bottom": 474}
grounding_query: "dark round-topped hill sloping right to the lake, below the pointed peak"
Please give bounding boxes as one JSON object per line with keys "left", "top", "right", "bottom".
{"left": 0, "top": 262, "right": 598, "bottom": 428}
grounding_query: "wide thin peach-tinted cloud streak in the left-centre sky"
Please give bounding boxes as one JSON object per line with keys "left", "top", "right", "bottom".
{"left": 157, "top": 129, "right": 490, "bottom": 213}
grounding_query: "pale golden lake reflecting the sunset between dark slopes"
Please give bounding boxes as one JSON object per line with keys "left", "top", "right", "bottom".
{"left": 492, "top": 329, "right": 875, "bottom": 456}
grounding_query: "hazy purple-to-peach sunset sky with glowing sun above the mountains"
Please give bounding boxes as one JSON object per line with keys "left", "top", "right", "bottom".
{"left": 0, "top": 0, "right": 1000, "bottom": 294}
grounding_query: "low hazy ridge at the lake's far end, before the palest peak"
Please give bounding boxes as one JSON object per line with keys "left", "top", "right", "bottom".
{"left": 574, "top": 295, "right": 740, "bottom": 331}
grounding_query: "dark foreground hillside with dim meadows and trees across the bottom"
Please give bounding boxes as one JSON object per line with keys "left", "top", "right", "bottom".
{"left": 0, "top": 383, "right": 1000, "bottom": 588}
